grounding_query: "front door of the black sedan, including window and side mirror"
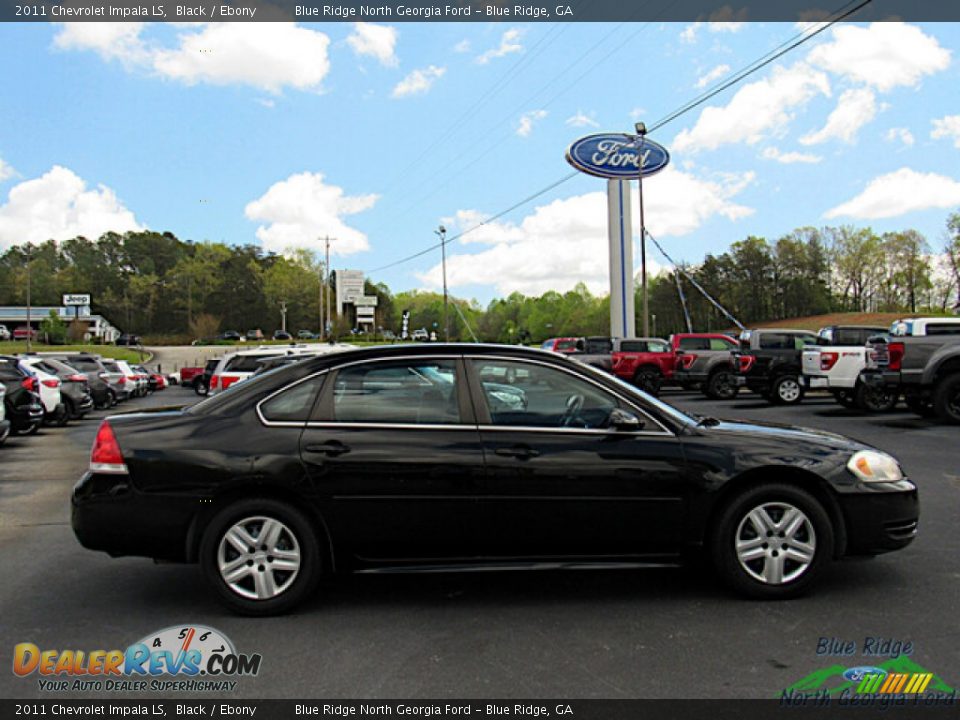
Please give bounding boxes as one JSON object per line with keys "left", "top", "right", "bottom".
{"left": 467, "top": 357, "right": 687, "bottom": 560}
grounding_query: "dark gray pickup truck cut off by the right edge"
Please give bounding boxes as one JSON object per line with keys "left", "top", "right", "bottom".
{"left": 860, "top": 335, "right": 960, "bottom": 424}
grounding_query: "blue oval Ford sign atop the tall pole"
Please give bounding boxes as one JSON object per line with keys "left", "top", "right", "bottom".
{"left": 567, "top": 133, "right": 670, "bottom": 180}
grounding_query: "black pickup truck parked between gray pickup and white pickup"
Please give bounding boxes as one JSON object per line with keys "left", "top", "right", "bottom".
{"left": 731, "top": 328, "right": 820, "bottom": 405}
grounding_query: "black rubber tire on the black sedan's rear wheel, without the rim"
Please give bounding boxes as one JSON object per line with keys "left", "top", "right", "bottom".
{"left": 200, "top": 498, "right": 322, "bottom": 617}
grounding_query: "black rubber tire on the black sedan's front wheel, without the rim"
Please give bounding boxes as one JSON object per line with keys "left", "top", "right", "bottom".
{"left": 709, "top": 483, "right": 834, "bottom": 600}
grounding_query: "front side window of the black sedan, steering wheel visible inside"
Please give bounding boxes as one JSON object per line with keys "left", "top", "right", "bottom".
{"left": 471, "top": 360, "right": 619, "bottom": 429}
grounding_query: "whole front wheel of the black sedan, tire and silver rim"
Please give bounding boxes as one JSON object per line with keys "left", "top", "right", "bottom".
{"left": 711, "top": 484, "right": 833, "bottom": 600}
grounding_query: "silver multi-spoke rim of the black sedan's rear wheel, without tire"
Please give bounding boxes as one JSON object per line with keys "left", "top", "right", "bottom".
{"left": 217, "top": 516, "right": 302, "bottom": 600}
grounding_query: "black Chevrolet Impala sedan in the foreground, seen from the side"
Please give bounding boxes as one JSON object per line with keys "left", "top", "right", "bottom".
{"left": 72, "top": 345, "right": 919, "bottom": 615}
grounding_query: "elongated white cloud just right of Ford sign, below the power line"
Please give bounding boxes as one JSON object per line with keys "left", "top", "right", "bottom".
{"left": 673, "top": 62, "right": 830, "bottom": 152}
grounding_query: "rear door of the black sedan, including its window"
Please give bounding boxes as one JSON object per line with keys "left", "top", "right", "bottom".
{"left": 300, "top": 355, "right": 484, "bottom": 564}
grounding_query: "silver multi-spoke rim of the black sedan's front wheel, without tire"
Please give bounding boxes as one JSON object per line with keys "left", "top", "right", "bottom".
{"left": 734, "top": 502, "right": 817, "bottom": 585}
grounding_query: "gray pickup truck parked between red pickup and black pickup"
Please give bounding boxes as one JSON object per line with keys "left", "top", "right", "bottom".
{"left": 670, "top": 333, "right": 740, "bottom": 400}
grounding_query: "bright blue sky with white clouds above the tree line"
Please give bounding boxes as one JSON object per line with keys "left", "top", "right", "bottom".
{"left": 0, "top": 23, "right": 960, "bottom": 301}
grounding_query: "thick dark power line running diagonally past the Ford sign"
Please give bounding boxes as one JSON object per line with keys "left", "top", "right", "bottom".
{"left": 370, "top": 0, "right": 873, "bottom": 276}
